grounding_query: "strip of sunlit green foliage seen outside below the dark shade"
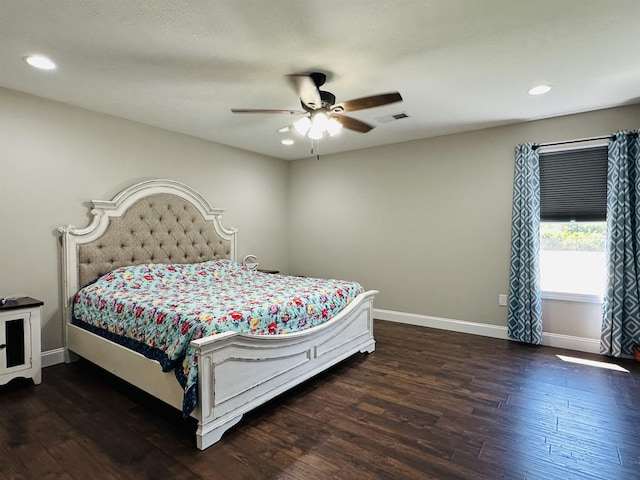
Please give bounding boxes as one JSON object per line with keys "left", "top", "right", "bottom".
{"left": 540, "top": 222, "right": 607, "bottom": 252}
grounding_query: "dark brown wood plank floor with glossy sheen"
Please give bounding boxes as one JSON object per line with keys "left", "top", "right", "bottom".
{"left": 0, "top": 321, "right": 640, "bottom": 480}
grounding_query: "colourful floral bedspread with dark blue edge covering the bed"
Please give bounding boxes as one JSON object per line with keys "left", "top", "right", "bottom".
{"left": 73, "top": 260, "right": 364, "bottom": 416}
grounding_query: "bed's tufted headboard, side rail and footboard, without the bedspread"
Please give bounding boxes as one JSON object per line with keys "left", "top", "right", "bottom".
{"left": 59, "top": 180, "right": 377, "bottom": 449}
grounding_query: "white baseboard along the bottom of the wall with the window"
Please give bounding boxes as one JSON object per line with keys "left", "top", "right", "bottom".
{"left": 373, "top": 308, "right": 600, "bottom": 353}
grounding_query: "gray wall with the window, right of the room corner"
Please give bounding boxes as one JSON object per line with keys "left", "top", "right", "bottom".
{"left": 289, "top": 105, "right": 640, "bottom": 337}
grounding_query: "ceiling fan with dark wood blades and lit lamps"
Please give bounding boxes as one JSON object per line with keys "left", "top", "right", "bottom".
{"left": 231, "top": 72, "right": 402, "bottom": 140}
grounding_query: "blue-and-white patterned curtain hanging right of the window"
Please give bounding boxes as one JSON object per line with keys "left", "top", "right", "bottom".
{"left": 600, "top": 131, "right": 640, "bottom": 356}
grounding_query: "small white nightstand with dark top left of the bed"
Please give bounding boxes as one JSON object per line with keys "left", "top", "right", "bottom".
{"left": 0, "top": 297, "right": 43, "bottom": 385}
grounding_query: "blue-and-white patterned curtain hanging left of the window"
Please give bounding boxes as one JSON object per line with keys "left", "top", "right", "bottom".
{"left": 507, "top": 143, "right": 542, "bottom": 345}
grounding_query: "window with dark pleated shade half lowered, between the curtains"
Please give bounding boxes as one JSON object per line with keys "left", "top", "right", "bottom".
{"left": 540, "top": 144, "right": 608, "bottom": 297}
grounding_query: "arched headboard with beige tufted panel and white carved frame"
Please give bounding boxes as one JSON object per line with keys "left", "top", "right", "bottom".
{"left": 58, "top": 180, "right": 237, "bottom": 321}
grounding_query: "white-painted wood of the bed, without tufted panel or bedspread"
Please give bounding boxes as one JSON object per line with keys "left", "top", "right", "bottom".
{"left": 59, "top": 180, "right": 378, "bottom": 449}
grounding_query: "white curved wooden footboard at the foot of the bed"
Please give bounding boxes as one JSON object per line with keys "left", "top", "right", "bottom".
{"left": 192, "top": 290, "right": 378, "bottom": 449}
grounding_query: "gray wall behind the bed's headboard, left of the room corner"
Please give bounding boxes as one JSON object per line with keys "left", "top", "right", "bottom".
{"left": 0, "top": 89, "right": 288, "bottom": 351}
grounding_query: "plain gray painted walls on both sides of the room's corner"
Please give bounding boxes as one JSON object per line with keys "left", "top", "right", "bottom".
{"left": 0, "top": 83, "right": 640, "bottom": 351}
